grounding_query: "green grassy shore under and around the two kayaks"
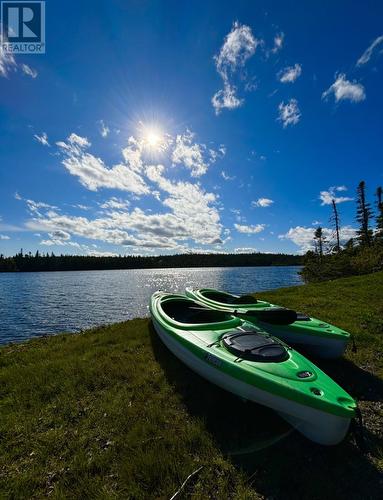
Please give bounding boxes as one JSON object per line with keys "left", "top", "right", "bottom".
{"left": 0, "top": 273, "right": 383, "bottom": 499}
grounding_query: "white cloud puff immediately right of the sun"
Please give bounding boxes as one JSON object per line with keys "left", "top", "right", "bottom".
{"left": 171, "top": 130, "right": 219, "bottom": 177}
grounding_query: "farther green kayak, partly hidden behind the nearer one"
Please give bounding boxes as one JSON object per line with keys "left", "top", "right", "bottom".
{"left": 186, "top": 288, "right": 350, "bottom": 359}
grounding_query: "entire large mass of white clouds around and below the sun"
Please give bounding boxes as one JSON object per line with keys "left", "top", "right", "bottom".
{"left": 30, "top": 127, "right": 225, "bottom": 251}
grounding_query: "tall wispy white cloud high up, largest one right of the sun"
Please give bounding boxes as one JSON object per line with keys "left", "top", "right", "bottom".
{"left": 211, "top": 22, "right": 261, "bottom": 115}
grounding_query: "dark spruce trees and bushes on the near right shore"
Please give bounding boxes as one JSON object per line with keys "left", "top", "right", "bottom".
{"left": 301, "top": 181, "right": 383, "bottom": 281}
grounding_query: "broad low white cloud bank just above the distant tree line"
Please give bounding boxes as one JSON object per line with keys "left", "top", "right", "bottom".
{"left": 26, "top": 166, "right": 222, "bottom": 251}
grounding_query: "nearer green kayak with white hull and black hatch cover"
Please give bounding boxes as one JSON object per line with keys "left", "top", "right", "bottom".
{"left": 150, "top": 292, "right": 356, "bottom": 445}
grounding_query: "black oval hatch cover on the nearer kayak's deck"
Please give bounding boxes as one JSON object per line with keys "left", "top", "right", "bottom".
{"left": 222, "top": 330, "right": 289, "bottom": 363}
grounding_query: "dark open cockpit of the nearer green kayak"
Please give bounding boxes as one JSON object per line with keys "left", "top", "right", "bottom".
{"left": 162, "top": 299, "right": 232, "bottom": 324}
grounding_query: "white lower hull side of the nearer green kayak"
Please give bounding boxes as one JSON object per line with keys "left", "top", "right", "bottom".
{"left": 152, "top": 316, "right": 351, "bottom": 445}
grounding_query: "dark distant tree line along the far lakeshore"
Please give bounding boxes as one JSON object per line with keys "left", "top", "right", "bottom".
{"left": 0, "top": 250, "right": 302, "bottom": 272}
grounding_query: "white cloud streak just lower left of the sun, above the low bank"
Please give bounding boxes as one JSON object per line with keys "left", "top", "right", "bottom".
{"left": 56, "top": 133, "right": 149, "bottom": 195}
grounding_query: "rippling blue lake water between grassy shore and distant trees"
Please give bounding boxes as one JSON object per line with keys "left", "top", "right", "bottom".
{"left": 0, "top": 266, "right": 301, "bottom": 344}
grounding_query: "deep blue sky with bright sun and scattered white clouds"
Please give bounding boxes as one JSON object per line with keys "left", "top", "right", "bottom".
{"left": 0, "top": 1, "right": 383, "bottom": 255}
